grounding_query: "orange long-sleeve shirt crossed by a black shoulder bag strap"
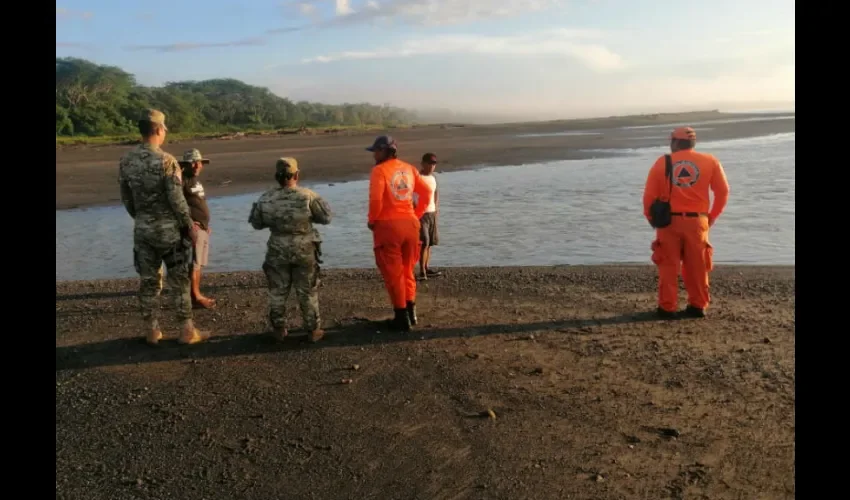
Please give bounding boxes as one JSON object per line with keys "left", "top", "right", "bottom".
{"left": 643, "top": 149, "right": 729, "bottom": 220}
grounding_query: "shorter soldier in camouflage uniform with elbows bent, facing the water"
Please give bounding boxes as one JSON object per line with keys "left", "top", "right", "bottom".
{"left": 248, "top": 158, "right": 331, "bottom": 342}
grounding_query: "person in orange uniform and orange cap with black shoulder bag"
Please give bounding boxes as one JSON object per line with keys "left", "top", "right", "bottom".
{"left": 643, "top": 127, "right": 729, "bottom": 319}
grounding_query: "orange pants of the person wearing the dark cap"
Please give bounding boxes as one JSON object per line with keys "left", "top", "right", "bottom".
{"left": 372, "top": 218, "right": 419, "bottom": 309}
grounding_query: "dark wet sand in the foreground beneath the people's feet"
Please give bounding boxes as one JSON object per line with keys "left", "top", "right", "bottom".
{"left": 56, "top": 266, "right": 796, "bottom": 500}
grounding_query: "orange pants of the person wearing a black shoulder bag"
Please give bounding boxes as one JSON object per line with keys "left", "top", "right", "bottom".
{"left": 652, "top": 216, "right": 714, "bottom": 312}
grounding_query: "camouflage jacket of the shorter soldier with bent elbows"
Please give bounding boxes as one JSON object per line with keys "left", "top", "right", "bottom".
{"left": 248, "top": 187, "right": 332, "bottom": 255}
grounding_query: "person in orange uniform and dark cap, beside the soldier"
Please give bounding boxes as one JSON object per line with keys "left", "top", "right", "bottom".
{"left": 366, "top": 135, "right": 431, "bottom": 331}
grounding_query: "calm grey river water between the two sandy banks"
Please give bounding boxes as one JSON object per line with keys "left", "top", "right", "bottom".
{"left": 56, "top": 132, "right": 795, "bottom": 280}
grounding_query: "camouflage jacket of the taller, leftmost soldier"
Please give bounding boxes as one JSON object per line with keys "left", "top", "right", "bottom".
{"left": 118, "top": 144, "right": 192, "bottom": 246}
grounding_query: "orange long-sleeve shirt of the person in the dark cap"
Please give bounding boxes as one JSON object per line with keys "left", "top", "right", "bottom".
{"left": 369, "top": 158, "right": 432, "bottom": 224}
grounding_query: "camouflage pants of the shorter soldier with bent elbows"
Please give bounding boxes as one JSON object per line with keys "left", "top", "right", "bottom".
{"left": 263, "top": 254, "right": 321, "bottom": 332}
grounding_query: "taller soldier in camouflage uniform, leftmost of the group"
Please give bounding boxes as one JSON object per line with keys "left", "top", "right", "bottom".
{"left": 118, "top": 109, "right": 207, "bottom": 345}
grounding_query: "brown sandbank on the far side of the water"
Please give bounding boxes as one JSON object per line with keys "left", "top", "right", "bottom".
{"left": 56, "top": 112, "right": 795, "bottom": 210}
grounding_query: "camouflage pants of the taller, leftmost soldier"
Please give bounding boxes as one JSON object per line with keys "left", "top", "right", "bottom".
{"left": 133, "top": 240, "right": 192, "bottom": 328}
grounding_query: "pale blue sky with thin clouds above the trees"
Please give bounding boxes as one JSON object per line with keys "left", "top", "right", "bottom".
{"left": 56, "top": 0, "right": 795, "bottom": 119}
